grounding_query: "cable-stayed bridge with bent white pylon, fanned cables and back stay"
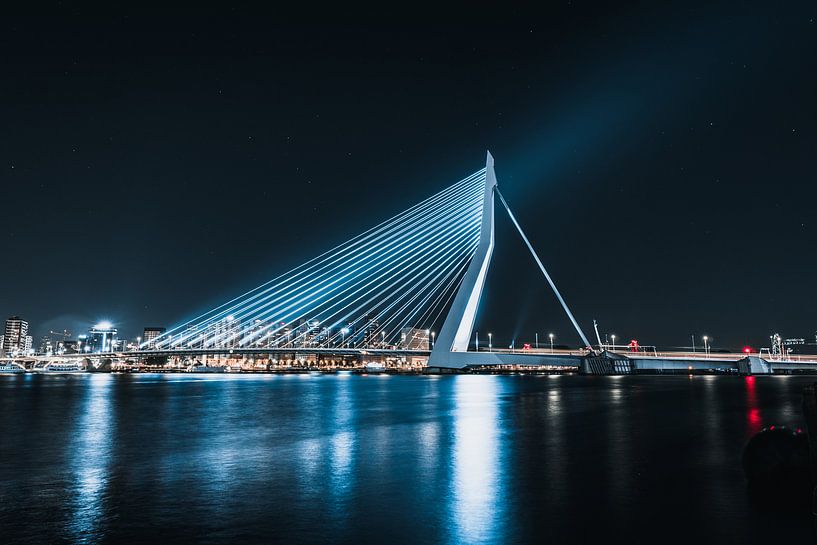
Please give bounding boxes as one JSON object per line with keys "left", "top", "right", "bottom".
{"left": 124, "top": 153, "right": 590, "bottom": 368}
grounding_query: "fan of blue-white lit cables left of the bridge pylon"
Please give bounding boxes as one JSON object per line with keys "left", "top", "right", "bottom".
{"left": 147, "top": 168, "right": 486, "bottom": 350}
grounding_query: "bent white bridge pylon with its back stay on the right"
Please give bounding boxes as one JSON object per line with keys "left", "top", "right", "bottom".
{"left": 428, "top": 152, "right": 590, "bottom": 369}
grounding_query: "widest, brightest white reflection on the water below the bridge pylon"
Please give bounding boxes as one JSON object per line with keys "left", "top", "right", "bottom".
{"left": 450, "top": 376, "right": 503, "bottom": 543}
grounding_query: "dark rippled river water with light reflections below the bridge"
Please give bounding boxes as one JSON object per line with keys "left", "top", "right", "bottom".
{"left": 0, "top": 375, "right": 814, "bottom": 544}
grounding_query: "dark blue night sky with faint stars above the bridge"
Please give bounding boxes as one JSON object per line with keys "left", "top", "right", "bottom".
{"left": 0, "top": 1, "right": 817, "bottom": 348}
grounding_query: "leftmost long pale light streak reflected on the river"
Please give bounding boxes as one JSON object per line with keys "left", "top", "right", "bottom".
{"left": 67, "top": 374, "right": 113, "bottom": 543}
